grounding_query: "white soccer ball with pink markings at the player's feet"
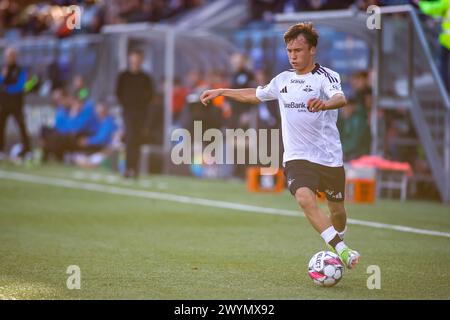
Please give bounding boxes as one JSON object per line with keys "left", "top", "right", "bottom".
{"left": 308, "top": 251, "right": 344, "bottom": 287}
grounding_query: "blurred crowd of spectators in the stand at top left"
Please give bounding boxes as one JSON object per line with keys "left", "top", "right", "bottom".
{"left": 0, "top": 0, "right": 203, "bottom": 39}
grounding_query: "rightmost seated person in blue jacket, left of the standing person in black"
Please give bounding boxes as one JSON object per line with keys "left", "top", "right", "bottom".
{"left": 78, "top": 102, "right": 117, "bottom": 153}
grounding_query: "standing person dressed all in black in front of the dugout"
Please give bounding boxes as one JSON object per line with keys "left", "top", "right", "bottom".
{"left": 116, "top": 50, "right": 153, "bottom": 178}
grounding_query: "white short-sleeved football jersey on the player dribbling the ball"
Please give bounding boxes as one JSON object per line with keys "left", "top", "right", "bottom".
{"left": 256, "top": 63, "right": 344, "bottom": 167}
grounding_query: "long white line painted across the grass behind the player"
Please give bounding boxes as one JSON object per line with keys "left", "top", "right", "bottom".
{"left": 0, "top": 170, "right": 450, "bottom": 238}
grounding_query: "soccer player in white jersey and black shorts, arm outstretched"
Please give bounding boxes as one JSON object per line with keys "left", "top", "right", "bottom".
{"left": 201, "top": 23, "right": 360, "bottom": 269}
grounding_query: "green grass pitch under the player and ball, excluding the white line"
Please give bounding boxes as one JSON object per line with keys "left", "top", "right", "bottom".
{"left": 0, "top": 164, "right": 450, "bottom": 299}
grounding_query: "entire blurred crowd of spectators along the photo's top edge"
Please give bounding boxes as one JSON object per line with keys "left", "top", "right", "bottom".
{"left": 0, "top": 0, "right": 417, "bottom": 38}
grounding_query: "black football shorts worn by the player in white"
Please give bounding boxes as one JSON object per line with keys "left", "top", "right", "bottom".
{"left": 284, "top": 160, "right": 345, "bottom": 202}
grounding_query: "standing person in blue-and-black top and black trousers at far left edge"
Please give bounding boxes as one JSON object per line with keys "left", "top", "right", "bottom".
{"left": 0, "top": 47, "right": 30, "bottom": 158}
